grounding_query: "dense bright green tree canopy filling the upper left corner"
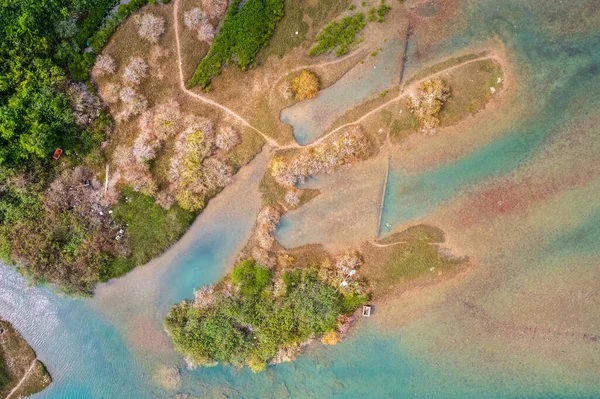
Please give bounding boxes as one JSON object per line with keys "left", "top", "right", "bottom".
{"left": 0, "top": 0, "right": 120, "bottom": 165}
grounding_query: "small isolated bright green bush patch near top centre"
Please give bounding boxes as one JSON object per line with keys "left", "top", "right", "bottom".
{"left": 309, "top": 13, "right": 365, "bottom": 57}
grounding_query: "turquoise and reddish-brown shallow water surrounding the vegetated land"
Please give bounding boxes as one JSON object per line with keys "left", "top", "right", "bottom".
{"left": 0, "top": 0, "right": 600, "bottom": 398}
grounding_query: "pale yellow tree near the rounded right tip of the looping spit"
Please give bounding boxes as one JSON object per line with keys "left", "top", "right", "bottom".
{"left": 408, "top": 78, "right": 450, "bottom": 132}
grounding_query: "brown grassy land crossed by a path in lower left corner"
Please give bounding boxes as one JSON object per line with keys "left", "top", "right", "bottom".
{"left": 0, "top": 320, "right": 52, "bottom": 398}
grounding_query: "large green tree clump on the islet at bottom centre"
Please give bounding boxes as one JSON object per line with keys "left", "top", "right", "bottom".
{"left": 165, "top": 260, "right": 369, "bottom": 371}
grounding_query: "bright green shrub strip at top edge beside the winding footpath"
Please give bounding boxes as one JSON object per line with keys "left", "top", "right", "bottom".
{"left": 188, "top": 0, "right": 283, "bottom": 89}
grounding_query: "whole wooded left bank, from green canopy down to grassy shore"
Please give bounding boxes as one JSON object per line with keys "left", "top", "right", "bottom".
{"left": 0, "top": 0, "right": 193, "bottom": 294}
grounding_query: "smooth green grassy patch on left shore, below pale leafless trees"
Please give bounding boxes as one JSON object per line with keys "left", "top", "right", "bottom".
{"left": 111, "top": 188, "right": 196, "bottom": 280}
